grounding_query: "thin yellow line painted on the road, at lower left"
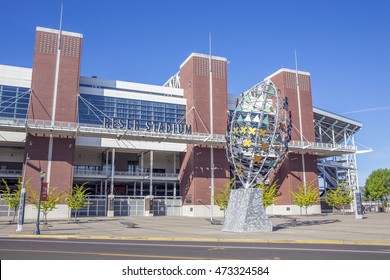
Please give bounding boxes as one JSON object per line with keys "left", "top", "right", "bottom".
{"left": 0, "top": 249, "right": 222, "bottom": 260}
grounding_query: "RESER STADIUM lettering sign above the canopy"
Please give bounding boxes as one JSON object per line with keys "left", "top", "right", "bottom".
{"left": 104, "top": 118, "right": 192, "bottom": 134}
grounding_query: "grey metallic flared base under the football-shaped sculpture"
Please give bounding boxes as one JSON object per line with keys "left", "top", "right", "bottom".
{"left": 222, "top": 188, "right": 272, "bottom": 232}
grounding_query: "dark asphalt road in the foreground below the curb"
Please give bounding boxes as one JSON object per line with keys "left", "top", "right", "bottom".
{"left": 0, "top": 238, "right": 390, "bottom": 260}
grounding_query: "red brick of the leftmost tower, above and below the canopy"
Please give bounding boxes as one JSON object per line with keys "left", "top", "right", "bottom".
{"left": 25, "top": 30, "right": 82, "bottom": 195}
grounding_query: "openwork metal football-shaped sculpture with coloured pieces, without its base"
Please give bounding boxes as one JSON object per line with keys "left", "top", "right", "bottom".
{"left": 226, "top": 80, "right": 291, "bottom": 188}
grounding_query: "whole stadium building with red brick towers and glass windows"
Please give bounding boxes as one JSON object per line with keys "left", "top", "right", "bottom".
{"left": 0, "top": 27, "right": 362, "bottom": 217}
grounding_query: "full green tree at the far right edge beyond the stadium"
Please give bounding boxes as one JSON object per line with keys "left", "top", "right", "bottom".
{"left": 364, "top": 168, "right": 390, "bottom": 206}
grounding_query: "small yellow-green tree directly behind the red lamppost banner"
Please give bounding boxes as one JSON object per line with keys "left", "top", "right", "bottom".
{"left": 27, "top": 187, "right": 64, "bottom": 224}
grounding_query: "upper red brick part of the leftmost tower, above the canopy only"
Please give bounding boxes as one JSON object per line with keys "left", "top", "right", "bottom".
{"left": 29, "top": 31, "right": 82, "bottom": 122}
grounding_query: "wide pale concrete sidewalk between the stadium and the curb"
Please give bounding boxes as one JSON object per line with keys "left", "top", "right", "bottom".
{"left": 0, "top": 213, "right": 390, "bottom": 246}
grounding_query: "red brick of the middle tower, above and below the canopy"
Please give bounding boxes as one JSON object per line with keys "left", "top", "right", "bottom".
{"left": 180, "top": 56, "right": 230, "bottom": 205}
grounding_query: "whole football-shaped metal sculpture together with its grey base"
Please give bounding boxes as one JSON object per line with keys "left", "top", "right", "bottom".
{"left": 223, "top": 80, "right": 291, "bottom": 232}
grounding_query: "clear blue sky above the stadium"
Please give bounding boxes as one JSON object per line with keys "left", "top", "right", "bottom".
{"left": 0, "top": 0, "right": 390, "bottom": 185}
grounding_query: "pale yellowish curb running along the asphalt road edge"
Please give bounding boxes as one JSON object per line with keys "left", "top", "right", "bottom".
{"left": 5, "top": 234, "right": 390, "bottom": 246}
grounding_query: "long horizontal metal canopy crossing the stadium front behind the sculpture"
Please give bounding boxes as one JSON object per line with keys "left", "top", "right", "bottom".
{"left": 0, "top": 115, "right": 357, "bottom": 156}
